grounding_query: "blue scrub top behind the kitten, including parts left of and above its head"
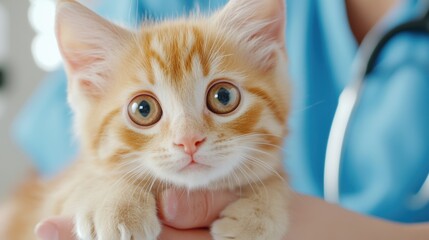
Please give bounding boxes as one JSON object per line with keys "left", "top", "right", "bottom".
{"left": 14, "top": 0, "right": 429, "bottom": 222}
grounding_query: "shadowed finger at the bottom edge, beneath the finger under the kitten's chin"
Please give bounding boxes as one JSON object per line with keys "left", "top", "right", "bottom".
{"left": 158, "top": 226, "right": 212, "bottom": 240}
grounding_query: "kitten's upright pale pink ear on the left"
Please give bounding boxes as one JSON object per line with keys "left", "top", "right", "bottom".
{"left": 56, "top": 0, "right": 130, "bottom": 95}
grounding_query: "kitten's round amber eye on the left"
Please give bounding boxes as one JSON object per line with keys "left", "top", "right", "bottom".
{"left": 128, "top": 94, "right": 162, "bottom": 127}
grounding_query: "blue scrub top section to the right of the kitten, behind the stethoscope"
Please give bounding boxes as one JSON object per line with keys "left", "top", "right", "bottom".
{"left": 286, "top": 0, "right": 429, "bottom": 222}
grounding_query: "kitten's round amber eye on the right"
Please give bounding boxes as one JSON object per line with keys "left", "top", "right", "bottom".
{"left": 207, "top": 82, "right": 241, "bottom": 114}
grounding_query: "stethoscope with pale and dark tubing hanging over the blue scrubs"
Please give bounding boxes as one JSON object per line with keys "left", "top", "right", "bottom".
{"left": 324, "top": 1, "right": 429, "bottom": 208}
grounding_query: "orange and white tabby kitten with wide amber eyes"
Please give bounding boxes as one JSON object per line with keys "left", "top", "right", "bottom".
{"left": 2, "top": 0, "right": 289, "bottom": 240}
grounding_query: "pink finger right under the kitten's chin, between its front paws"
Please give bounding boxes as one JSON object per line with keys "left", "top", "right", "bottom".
{"left": 159, "top": 189, "right": 238, "bottom": 229}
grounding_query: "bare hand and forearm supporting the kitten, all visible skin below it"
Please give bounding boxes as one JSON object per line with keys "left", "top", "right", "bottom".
{"left": 32, "top": 190, "right": 429, "bottom": 240}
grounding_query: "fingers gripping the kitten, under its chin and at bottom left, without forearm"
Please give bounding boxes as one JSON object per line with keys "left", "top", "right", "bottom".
{"left": 36, "top": 190, "right": 237, "bottom": 240}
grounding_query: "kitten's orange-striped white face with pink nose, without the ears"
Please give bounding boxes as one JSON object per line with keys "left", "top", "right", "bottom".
{"left": 55, "top": 0, "right": 288, "bottom": 188}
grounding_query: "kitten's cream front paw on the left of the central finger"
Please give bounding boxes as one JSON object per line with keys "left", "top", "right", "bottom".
{"left": 75, "top": 197, "right": 161, "bottom": 240}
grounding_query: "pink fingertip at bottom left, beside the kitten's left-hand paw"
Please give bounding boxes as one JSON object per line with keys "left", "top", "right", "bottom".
{"left": 35, "top": 217, "right": 76, "bottom": 240}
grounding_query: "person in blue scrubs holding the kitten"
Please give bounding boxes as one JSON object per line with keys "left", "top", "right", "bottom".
{"left": 5, "top": 0, "right": 429, "bottom": 240}
